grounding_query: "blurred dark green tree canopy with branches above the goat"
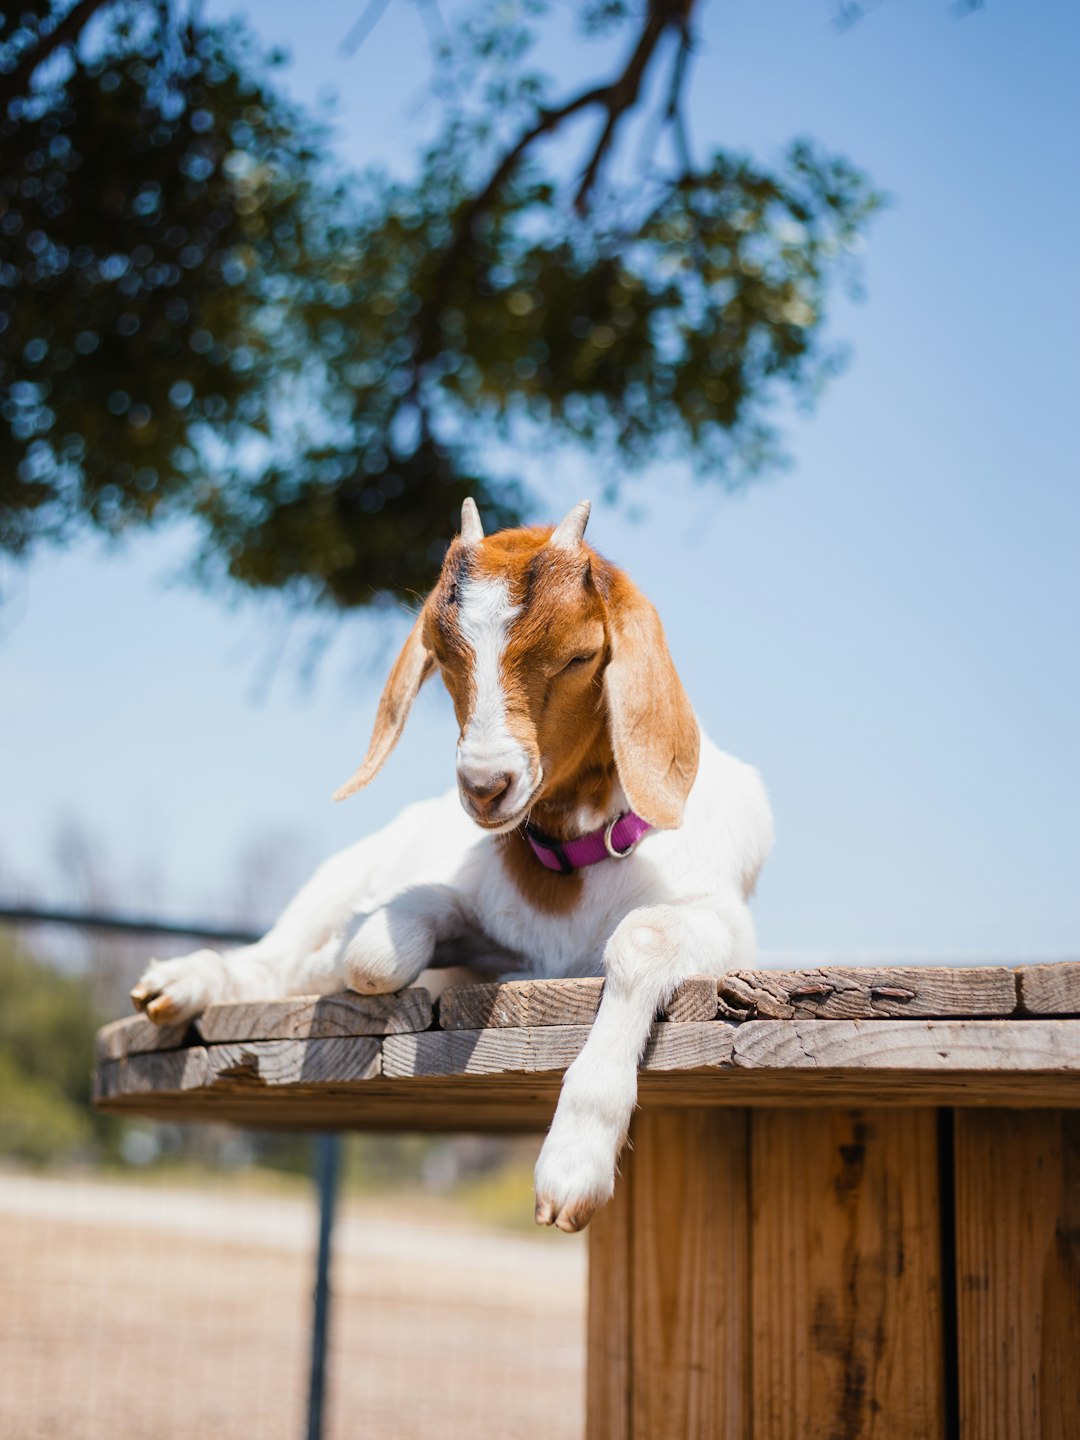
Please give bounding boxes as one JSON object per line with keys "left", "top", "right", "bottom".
{"left": 0, "top": 0, "right": 878, "bottom": 606}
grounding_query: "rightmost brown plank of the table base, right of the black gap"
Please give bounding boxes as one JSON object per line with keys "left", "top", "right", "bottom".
{"left": 955, "top": 1110, "right": 1080, "bottom": 1440}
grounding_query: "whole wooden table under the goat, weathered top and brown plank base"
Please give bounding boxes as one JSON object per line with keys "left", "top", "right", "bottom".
{"left": 95, "top": 963, "right": 1080, "bottom": 1440}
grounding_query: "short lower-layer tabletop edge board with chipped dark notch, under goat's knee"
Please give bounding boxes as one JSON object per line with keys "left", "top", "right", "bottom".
{"left": 204, "top": 1035, "right": 382, "bottom": 1089}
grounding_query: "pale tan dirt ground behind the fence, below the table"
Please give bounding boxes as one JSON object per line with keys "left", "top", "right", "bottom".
{"left": 0, "top": 1175, "right": 585, "bottom": 1440}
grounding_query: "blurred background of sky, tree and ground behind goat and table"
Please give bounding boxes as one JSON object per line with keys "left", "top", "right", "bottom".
{"left": 0, "top": 0, "right": 1080, "bottom": 1440}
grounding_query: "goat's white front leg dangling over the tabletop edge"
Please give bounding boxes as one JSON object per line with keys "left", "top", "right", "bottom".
{"left": 536, "top": 901, "right": 755, "bottom": 1231}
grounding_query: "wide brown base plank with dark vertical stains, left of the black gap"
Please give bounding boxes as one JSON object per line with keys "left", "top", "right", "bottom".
{"left": 754, "top": 1109, "right": 943, "bottom": 1440}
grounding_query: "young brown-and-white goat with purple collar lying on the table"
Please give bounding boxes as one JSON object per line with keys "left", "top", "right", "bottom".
{"left": 131, "top": 500, "right": 772, "bottom": 1231}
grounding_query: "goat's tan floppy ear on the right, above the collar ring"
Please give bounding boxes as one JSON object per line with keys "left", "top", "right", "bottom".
{"left": 603, "top": 576, "right": 701, "bottom": 829}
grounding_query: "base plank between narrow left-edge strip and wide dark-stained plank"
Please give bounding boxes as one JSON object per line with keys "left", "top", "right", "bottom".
{"left": 630, "top": 1109, "right": 748, "bottom": 1440}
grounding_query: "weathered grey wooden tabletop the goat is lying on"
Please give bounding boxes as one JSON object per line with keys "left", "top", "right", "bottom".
{"left": 95, "top": 963, "right": 1080, "bottom": 1132}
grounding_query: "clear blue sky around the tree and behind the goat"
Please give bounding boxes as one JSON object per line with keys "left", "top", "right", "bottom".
{"left": 0, "top": 0, "right": 1080, "bottom": 959}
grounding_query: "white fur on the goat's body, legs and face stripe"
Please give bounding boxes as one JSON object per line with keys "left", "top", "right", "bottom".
{"left": 141, "top": 731, "right": 772, "bottom": 1230}
